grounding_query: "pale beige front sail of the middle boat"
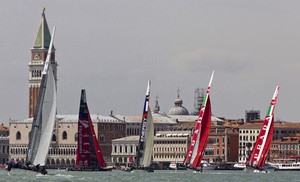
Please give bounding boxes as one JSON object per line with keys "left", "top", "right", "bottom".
{"left": 141, "top": 107, "right": 154, "bottom": 167}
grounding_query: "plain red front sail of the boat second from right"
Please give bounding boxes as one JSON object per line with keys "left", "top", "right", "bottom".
{"left": 191, "top": 96, "right": 211, "bottom": 168}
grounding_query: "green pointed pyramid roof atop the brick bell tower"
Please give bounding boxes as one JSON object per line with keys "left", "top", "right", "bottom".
{"left": 33, "top": 8, "right": 51, "bottom": 48}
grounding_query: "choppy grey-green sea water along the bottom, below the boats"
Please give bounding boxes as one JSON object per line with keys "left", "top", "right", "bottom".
{"left": 0, "top": 169, "right": 300, "bottom": 182}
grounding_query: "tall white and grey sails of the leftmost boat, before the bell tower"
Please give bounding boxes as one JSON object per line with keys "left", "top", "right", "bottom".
{"left": 26, "top": 27, "right": 56, "bottom": 166}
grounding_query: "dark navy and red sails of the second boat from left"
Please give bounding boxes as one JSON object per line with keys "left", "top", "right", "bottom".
{"left": 76, "top": 89, "right": 106, "bottom": 167}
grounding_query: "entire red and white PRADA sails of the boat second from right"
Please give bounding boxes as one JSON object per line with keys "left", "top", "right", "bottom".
{"left": 184, "top": 72, "right": 214, "bottom": 168}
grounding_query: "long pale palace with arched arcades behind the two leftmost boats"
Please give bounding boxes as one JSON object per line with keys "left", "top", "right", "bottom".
{"left": 9, "top": 115, "right": 126, "bottom": 167}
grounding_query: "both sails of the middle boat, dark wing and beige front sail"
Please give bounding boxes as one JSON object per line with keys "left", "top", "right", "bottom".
{"left": 136, "top": 81, "right": 154, "bottom": 167}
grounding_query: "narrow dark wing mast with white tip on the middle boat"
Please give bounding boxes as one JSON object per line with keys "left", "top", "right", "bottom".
{"left": 136, "top": 80, "right": 151, "bottom": 167}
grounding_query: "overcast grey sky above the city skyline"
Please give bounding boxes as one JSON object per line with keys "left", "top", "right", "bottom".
{"left": 0, "top": 0, "right": 300, "bottom": 123}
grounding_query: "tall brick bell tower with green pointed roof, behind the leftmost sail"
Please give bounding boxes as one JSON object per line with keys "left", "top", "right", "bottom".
{"left": 28, "top": 8, "right": 58, "bottom": 118}
